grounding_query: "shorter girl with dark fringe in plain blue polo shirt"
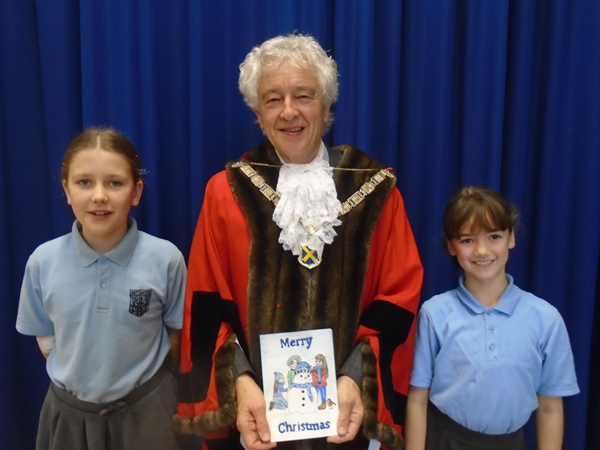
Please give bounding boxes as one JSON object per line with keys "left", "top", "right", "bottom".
{"left": 405, "top": 187, "right": 579, "bottom": 450}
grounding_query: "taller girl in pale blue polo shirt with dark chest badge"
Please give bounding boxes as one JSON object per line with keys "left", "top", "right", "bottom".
{"left": 17, "top": 128, "right": 186, "bottom": 450}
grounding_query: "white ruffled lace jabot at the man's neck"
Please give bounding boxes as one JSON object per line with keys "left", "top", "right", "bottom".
{"left": 273, "top": 142, "right": 342, "bottom": 255}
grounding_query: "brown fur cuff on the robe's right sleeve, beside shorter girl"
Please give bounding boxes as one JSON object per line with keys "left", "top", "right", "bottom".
{"left": 361, "top": 338, "right": 404, "bottom": 450}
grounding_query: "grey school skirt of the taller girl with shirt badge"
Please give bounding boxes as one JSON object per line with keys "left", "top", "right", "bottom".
{"left": 36, "top": 367, "right": 178, "bottom": 450}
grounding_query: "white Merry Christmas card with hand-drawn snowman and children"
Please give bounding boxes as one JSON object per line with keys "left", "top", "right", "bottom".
{"left": 260, "top": 328, "right": 339, "bottom": 442}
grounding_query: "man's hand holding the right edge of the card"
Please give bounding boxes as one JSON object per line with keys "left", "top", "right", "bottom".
{"left": 327, "top": 375, "right": 365, "bottom": 444}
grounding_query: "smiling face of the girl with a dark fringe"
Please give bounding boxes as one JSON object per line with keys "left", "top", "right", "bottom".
{"left": 448, "top": 224, "right": 515, "bottom": 292}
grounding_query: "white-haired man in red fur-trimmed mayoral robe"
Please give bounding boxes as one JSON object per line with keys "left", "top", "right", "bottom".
{"left": 176, "top": 35, "right": 422, "bottom": 450}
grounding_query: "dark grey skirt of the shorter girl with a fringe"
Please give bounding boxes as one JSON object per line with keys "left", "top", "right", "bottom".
{"left": 425, "top": 402, "right": 527, "bottom": 450}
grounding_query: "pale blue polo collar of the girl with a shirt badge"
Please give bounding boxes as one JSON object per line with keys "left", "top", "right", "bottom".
{"left": 72, "top": 217, "right": 139, "bottom": 267}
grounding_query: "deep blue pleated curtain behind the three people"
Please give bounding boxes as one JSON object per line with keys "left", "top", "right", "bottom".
{"left": 0, "top": 0, "right": 600, "bottom": 450}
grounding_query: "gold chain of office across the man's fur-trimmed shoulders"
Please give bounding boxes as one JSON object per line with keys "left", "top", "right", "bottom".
{"left": 231, "top": 161, "right": 396, "bottom": 217}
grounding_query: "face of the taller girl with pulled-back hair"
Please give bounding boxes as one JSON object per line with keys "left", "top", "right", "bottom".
{"left": 63, "top": 148, "right": 144, "bottom": 254}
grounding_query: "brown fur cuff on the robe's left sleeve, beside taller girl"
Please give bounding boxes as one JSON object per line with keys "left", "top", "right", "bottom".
{"left": 173, "top": 334, "right": 237, "bottom": 436}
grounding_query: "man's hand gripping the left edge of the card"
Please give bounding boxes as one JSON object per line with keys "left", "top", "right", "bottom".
{"left": 235, "top": 374, "right": 277, "bottom": 450}
